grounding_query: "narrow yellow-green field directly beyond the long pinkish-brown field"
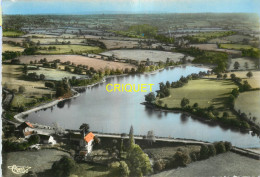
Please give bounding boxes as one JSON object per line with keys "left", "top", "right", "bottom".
{"left": 37, "top": 45, "right": 102, "bottom": 54}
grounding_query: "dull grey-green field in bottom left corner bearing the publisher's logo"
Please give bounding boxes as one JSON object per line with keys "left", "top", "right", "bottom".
{"left": 2, "top": 149, "right": 69, "bottom": 177}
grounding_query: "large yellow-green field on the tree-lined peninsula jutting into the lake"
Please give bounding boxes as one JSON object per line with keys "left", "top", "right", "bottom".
{"left": 157, "top": 79, "right": 237, "bottom": 118}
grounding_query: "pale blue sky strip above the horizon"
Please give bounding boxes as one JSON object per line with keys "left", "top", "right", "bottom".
{"left": 2, "top": 0, "right": 260, "bottom": 14}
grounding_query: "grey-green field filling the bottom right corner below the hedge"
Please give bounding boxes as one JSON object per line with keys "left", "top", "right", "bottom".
{"left": 152, "top": 152, "right": 260, "bottom": 177}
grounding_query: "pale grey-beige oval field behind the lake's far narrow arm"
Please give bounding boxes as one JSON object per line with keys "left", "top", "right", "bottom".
{"left": 101, "top": 50, "right": 193, "bottom": 62}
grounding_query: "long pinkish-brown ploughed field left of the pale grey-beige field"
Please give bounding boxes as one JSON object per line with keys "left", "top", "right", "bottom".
{"left": 19, "top": 55, "right": 136, "bottom": 70}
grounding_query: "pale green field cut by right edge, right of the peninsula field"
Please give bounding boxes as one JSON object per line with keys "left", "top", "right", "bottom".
{"left": 235, "top": 90, "right": 260, "bottom": 123}
